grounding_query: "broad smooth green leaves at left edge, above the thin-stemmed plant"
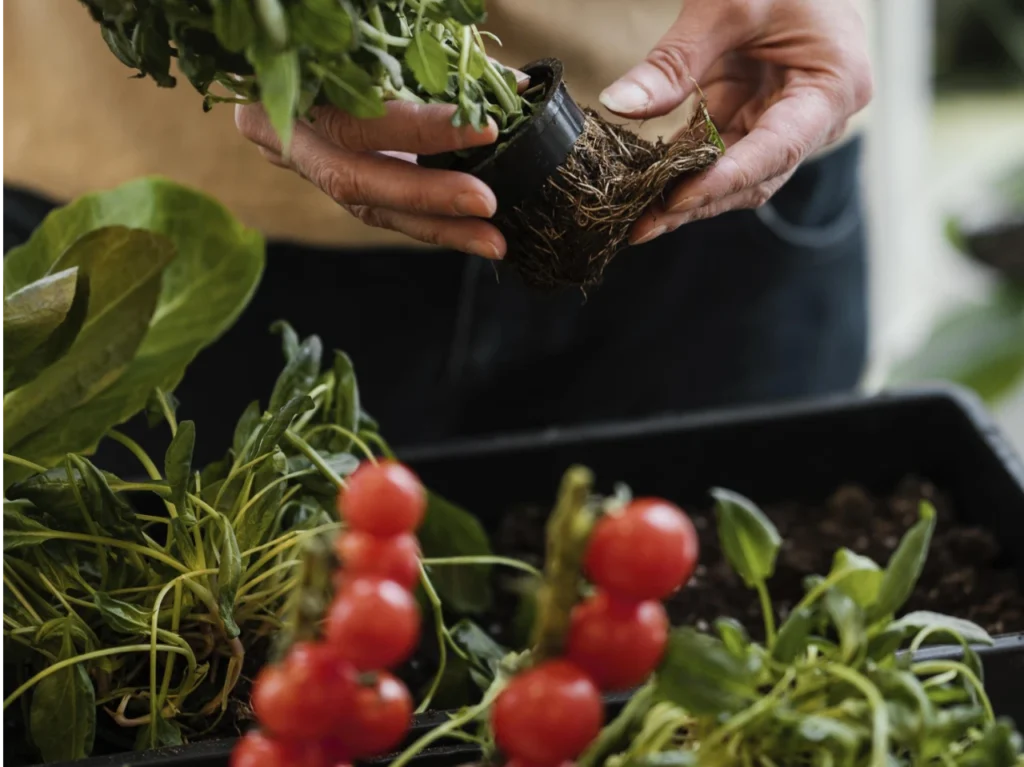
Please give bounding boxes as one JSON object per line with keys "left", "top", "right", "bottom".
{"left": 3, "top": 178, "right": 263, "bottom": 486}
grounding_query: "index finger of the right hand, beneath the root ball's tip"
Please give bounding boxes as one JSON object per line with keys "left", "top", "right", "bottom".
{"left": 666, "top": 88, "right": 842, "bottom": 218}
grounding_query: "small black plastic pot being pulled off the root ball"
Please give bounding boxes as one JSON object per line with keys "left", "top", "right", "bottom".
{"left": 419, "top": 58, "right": 584, "bottom": 211}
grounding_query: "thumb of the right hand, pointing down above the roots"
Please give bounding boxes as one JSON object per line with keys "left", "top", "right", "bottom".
{"left": 600, "top": 0, "right": 761, "bottom": 119}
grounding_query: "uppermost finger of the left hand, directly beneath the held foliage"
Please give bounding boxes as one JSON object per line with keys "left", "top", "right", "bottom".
{"left": 310, "top": 101, "right": 498, "bottom": 155}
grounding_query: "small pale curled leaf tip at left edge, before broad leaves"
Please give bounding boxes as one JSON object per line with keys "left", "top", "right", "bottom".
{"left": 0, "top": 266, "right": 78, "bottom": 367}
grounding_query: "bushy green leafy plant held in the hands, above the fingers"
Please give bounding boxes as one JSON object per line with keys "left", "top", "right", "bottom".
{"left": 82, "top": 0, "right": 527, "bottom": 147}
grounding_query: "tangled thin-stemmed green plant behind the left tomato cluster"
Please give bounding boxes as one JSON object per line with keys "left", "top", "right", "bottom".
{"left": 2, "top": 323, "right": 501, "bottom": 762}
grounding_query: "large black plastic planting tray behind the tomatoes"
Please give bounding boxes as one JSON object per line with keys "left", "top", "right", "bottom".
{"left": 37, "top": 387, "right": 1024, "bottom": 767}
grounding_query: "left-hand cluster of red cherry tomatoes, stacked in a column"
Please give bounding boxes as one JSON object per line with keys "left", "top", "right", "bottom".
{"left": 231, "top": 461, "right": 426, "bottom": 767}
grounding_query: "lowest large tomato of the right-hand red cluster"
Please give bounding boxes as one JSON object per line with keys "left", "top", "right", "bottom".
{"left": 490, "top": 659, "right": 604, "bottom": 765}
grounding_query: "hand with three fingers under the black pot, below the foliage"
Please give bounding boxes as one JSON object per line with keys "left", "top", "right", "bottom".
{"left": 234, "top": 101, "right": 506, "bottom": 258}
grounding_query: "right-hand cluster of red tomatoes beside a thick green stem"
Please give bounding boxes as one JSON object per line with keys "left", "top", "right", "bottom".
{"left": 490, "top": 499, "right": 698, "bottom": 767}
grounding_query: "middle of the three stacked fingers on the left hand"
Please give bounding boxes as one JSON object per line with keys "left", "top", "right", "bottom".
{"left": 291, "top": 124, "right": 498, "bottom": 218}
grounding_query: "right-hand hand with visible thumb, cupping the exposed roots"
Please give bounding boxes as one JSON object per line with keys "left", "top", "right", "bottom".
{"left": 601, "top": 0, "right": 872, "bottom": 244}
